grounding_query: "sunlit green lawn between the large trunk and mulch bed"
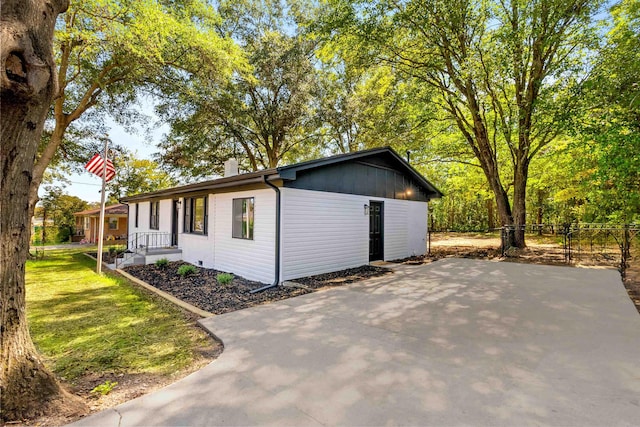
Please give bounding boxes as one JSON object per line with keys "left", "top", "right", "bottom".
{"left": 26, "top": 249, "right": 209, "bottom": 382}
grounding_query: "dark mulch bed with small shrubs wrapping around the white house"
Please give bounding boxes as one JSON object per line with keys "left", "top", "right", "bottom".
{"left": 124, "top": 261, "right": 390, "bottom": 314}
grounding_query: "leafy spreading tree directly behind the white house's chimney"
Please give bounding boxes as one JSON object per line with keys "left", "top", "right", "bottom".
{"left": 161, "top": 30, "right": 318, "bottom": 176}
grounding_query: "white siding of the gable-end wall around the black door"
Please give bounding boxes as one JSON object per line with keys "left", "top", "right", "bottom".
{"left": 281, "top": 188, "right": 427, "bottom": 280}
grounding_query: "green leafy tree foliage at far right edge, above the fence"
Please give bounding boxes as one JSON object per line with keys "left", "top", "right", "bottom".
{"left": 572, "top": 0, "right": 640, "bottom": 223}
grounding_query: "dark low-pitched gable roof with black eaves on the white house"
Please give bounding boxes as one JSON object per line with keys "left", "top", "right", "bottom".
{"left": 120, "top": 147, "right": 443, "bottom": 203}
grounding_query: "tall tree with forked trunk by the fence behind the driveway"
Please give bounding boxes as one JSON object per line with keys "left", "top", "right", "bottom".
{"left": 319, "top": 0, "right": 600, "bottom": 247}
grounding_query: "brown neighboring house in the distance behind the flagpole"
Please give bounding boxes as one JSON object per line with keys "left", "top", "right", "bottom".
{"left": 72, "top": 204, "right": 128, "bottom": 243}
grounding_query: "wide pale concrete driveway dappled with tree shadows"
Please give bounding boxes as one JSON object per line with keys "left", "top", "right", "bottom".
{"left": 76, "top": 259, "right": 640, "bottom": 426}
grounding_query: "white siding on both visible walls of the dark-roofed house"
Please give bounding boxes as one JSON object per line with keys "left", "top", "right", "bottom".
{"left": 124, "top": 188, "right": 427, "bottom": 283}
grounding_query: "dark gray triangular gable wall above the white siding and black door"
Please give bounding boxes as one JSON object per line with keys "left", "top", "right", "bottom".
{"left": 284, "top": 157, "right": 434, "bottom": 202}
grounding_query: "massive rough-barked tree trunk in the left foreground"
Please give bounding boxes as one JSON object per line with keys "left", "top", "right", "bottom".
{"left": 0, "top": 0, "right": 85, "bottom": 421}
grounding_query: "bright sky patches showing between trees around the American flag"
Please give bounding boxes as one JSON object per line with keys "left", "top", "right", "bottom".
{"left": 38, "top": 111, "right": 169, "bottom": 203}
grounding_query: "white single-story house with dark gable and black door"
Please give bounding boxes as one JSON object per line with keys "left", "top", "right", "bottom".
{"left": 122, "top": 147, "right": 442, "bottom": 284}
